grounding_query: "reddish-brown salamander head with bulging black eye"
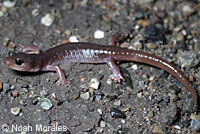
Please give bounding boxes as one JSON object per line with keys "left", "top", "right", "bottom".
{"left": 4, "top": 53, "right": 41, "bottom": 72}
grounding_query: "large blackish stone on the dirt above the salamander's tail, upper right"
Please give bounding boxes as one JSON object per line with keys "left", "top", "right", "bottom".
{"left": 144, "top": 25, "right": 164, "bottom": 43}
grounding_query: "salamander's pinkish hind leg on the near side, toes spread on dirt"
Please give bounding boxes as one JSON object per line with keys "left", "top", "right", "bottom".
{"left": 107, "top": 60, "right": 124, "bottom": 83}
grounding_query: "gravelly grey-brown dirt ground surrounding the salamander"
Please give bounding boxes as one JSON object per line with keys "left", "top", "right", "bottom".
{"left": 0, "top": 0, "right": 200, "bottom": 134}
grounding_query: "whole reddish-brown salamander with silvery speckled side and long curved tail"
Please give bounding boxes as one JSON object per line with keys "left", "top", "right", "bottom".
{"left": 4, "top": 37, "right": 198, "bottom": 107}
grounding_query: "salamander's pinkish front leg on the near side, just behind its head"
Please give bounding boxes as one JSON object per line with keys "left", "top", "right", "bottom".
{"left": 46, "top": 65, "right": 67, "bottom": 85}
